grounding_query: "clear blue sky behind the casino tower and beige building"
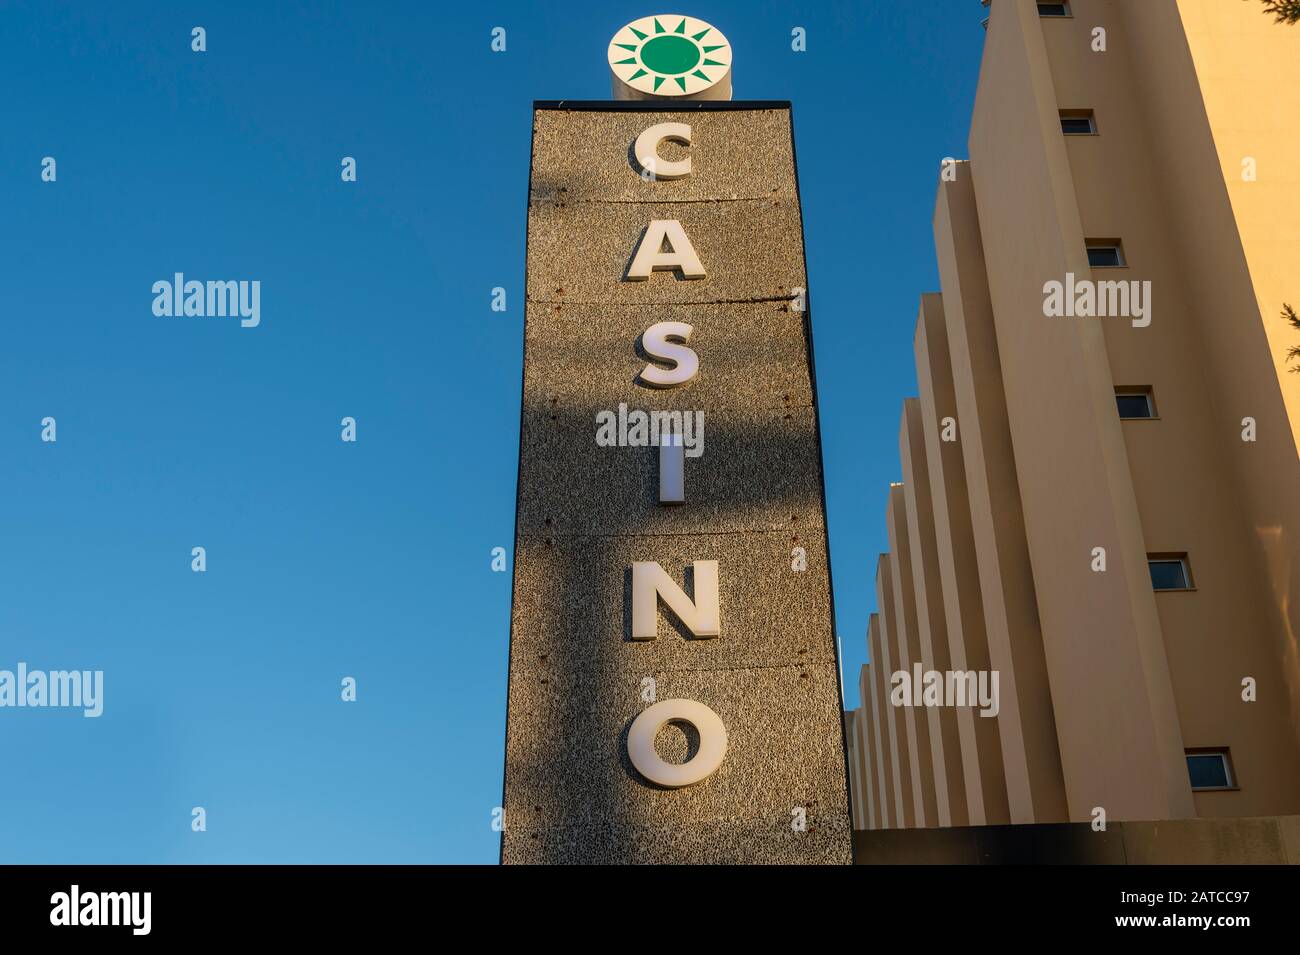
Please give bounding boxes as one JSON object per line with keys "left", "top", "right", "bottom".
{"left": 0, "top": 0, "right": 984, "bottom": 863}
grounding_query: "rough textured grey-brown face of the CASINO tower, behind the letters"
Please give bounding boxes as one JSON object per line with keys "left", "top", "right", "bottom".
{"left": 502, "top": 109, "right": 852, "bottom": 863}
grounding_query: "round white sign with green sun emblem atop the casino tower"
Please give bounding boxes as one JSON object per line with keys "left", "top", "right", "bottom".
{"left": 610, "top": 13, "right": 731, "bottom": 100}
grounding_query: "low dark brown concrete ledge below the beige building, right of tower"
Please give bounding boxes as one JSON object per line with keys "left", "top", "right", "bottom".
{"left": 853, "top": 816, "right": 1300, "bottom": 865}
